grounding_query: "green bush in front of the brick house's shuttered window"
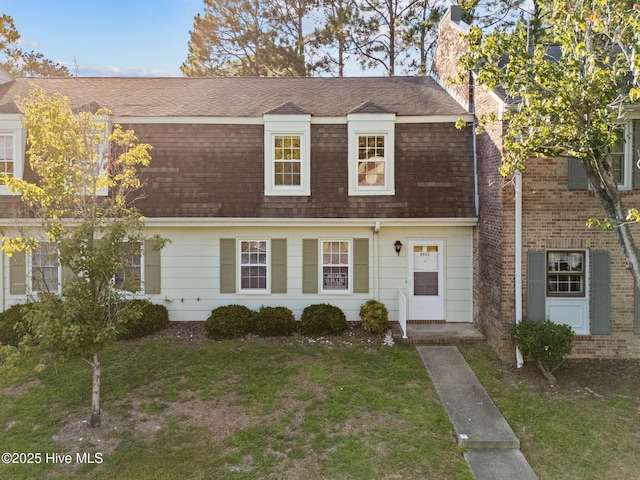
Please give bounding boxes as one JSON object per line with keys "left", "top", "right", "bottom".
{"left": 511, "top": 320, "right": 576, "bottom": 385}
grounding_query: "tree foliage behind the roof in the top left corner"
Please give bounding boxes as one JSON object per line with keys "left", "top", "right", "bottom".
{"left": 0, "top": 14, "right": 69, "bottom": 77}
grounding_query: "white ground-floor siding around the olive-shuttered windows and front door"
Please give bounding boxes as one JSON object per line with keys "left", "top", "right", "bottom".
{"left": 0, "top": 222, "right": 473, "bottom": 322}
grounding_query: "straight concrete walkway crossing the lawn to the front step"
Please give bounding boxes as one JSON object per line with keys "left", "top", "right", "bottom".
{"left": 417, "top": 346, "right": 538, "bottom": 480}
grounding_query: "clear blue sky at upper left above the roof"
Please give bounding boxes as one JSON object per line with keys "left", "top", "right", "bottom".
{"left": 0, "top": 0, "right": 204, "bottom": 77}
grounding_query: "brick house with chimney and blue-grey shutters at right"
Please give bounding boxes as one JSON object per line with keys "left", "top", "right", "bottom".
{"left": 433, "top": 7, "right": 640, "bottom": 359}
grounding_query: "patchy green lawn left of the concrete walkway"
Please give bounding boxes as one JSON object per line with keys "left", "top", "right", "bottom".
{"left": 0, "top": 337, "right": 472, "bottom": 479}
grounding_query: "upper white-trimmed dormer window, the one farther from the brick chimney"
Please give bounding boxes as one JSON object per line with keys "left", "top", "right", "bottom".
{"left": 264, "top": 114, "right": 311, "bottom": 196}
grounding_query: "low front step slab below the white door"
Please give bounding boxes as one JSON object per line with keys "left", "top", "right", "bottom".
{"left": 392, "top": 322, "right": 485, "bottom": 345}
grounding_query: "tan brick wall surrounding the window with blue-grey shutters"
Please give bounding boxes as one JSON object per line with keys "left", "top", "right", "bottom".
{"left": 522, "top": 158, "right": 640, "bottom": 358}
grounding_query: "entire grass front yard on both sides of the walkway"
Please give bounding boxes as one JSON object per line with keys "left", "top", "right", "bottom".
{"left": 0, "top": 326, "right": 640, "bottom": 479}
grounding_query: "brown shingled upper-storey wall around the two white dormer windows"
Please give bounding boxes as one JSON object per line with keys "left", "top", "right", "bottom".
{"left": 111, "top": 123, "right": 475, "bottom": 218}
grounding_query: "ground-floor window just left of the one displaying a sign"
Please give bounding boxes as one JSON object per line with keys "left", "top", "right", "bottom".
{"left": 238, "top": 240, "right": 269, "bottom": 293}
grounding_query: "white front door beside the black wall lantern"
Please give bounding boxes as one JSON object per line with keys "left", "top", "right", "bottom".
{"left": 407, "top": 240, "right": 445, "bottom": 320}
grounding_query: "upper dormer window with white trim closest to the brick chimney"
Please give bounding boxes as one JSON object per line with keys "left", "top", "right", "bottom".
{"left": 347, "top": 113, "right": 395, "bottom": 195}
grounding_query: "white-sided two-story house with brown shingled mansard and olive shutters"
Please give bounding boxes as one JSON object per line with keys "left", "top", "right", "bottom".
{"left": 0, "top": 72, "right": 477, "bottom": 334}
